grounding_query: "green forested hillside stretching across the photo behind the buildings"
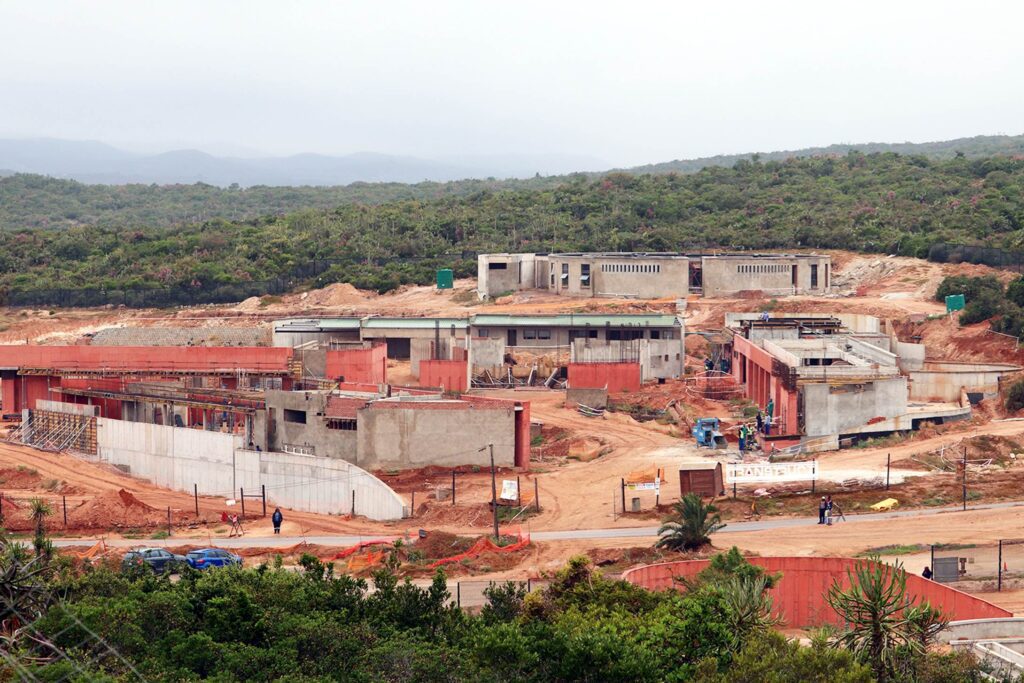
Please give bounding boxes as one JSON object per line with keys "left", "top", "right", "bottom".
{"left": 0, "top": 153, "right": 1024, "bottom": 305}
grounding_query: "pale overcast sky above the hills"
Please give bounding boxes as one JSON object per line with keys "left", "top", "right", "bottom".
{"left": 0, "top": 0, "right": 1024, "bottom": 166}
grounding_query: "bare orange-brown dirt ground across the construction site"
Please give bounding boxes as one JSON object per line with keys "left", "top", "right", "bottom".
{"left": 9, "top": 252, "right": 1024, "bottom": 610}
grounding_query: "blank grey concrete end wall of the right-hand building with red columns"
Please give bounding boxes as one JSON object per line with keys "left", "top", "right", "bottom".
{"left": 800, "top": 377, "right": 907, "bottom": 437}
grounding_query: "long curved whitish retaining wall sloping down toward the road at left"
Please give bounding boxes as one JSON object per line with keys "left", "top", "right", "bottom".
{"left": 96, "top": 418, "right": 404, "bottom": 520}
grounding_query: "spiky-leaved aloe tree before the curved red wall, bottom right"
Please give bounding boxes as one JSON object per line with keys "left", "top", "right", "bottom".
{"left": 827, "top": 558, "right": 939, "bottom": 683}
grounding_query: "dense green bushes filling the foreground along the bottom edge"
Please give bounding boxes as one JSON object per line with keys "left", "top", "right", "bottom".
{"left": 0, "top": 541, "right": 980, "bottom": 683}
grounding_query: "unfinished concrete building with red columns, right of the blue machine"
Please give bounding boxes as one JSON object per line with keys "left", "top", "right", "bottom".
{"left": 723, "top": 313, "right": 1019, "bottom": 450}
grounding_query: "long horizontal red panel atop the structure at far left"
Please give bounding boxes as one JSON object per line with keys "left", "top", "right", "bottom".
{"left": 0, "top": 345, "right": 292, "bottom": 375}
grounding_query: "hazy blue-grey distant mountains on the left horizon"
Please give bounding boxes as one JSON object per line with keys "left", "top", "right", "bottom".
{"left": 0, "top": 138, "right": 606, "bottom": 187}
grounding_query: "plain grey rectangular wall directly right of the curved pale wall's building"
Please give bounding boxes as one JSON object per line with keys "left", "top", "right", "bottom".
{"left": 356, "top": 400, "right": 516, "bottom": 469}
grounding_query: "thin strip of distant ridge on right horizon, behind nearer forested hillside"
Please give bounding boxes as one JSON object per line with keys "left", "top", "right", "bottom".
{"left": 620, "top": 135, "right": 1024, "bottom": 173}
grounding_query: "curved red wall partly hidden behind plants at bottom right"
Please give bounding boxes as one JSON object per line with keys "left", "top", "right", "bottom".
{"left": 623, "top": 557, "right": 1013, "bottom": 629}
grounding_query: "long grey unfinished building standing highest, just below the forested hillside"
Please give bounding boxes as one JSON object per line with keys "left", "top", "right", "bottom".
{"left": 477, "top": 248, "right": 831, "bottom": 299}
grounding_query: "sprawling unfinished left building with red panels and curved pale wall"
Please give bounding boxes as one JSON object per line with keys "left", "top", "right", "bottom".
{"left": 0, "top": 343, "right": 529, "bottom": 519}
